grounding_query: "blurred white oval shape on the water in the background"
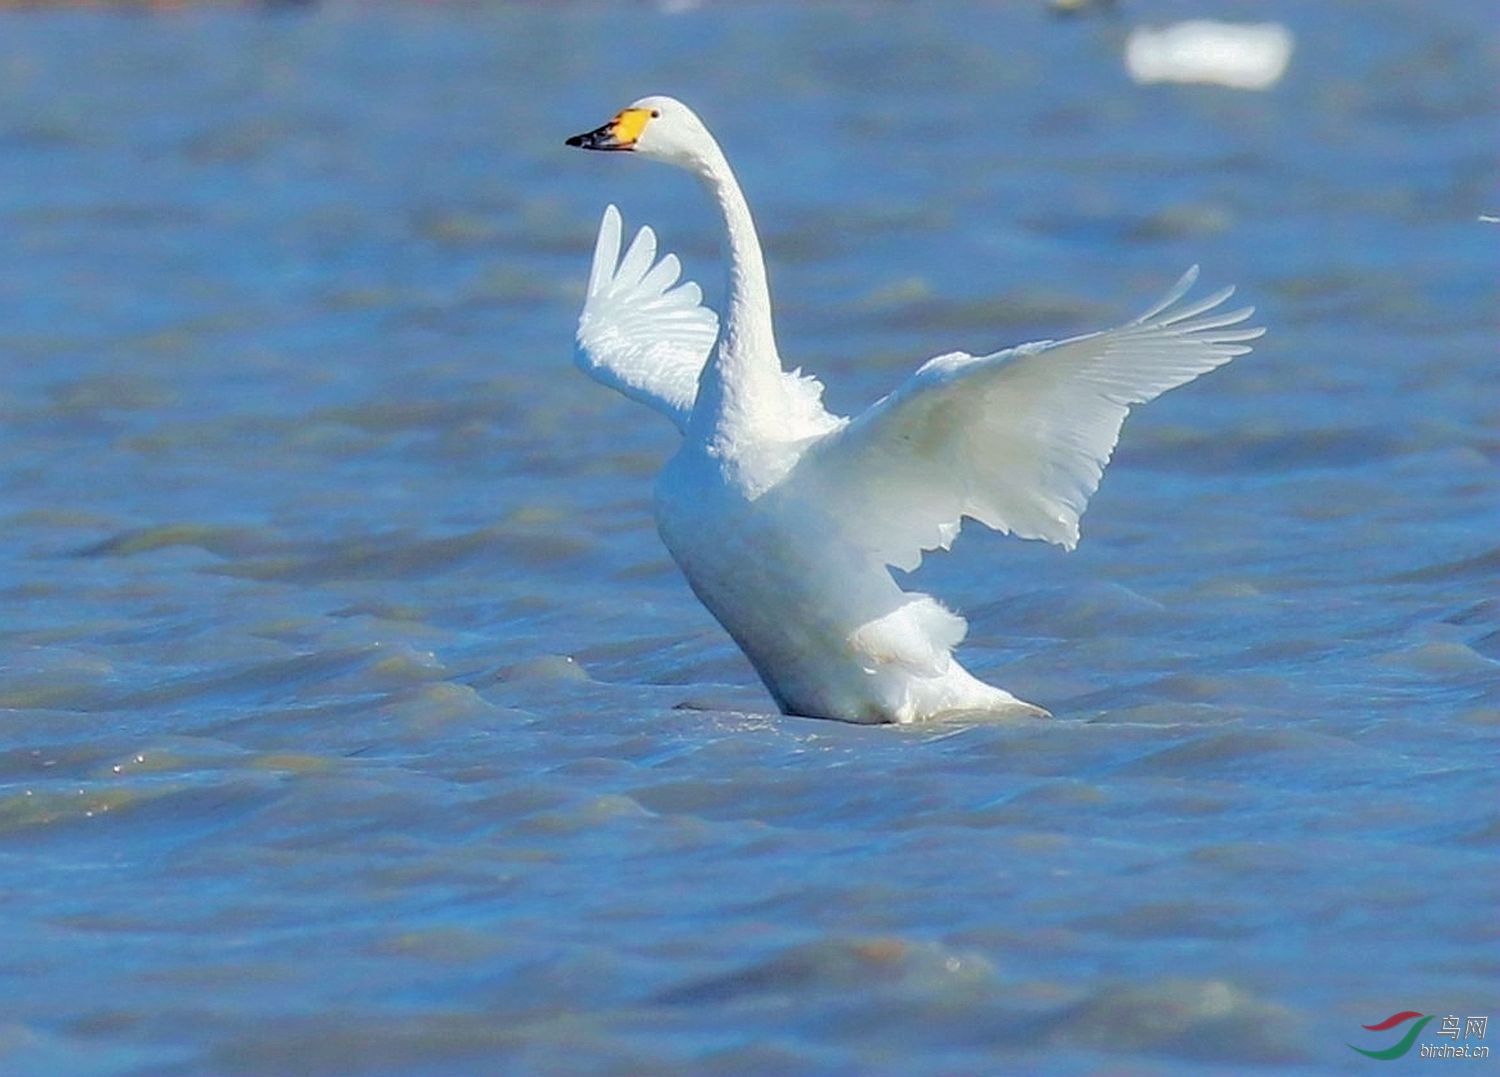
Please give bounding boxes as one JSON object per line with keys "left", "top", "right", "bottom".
{"left": 1125, "top": 20, "right": 1295, "bottom": 90}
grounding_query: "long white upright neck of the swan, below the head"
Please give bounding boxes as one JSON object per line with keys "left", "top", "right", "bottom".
{"left": 693, "top": 144, "right": 782, "bottom": 437}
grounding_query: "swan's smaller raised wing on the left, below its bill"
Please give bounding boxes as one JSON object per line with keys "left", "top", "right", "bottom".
{"left": 575, "top": 206, "right": 719, "bottom": 429}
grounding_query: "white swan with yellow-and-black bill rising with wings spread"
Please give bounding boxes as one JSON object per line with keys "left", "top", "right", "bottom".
{"left": 567, "top": 98, "right": 1263, "bottom": 723}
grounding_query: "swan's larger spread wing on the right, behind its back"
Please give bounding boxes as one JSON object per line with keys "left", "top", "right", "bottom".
{"left": 798, "top": 266, "right": 1265, "bottom": 570}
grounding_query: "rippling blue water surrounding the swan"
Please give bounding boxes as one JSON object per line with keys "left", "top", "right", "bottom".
{"left": 0, "top": 0, "right": 1500, "bottom": 1077}
